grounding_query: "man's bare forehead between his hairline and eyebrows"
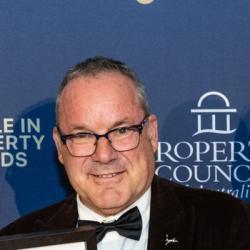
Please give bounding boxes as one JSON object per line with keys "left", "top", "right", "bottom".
{"left": 59, "top": 72, "right": 141, "bottom": 128}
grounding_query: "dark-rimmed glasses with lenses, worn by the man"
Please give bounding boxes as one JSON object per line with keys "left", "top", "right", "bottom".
{"left": 57, "top": 115, "right": 149, "bottom": 157}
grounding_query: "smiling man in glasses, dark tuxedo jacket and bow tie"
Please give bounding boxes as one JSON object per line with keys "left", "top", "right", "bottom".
{"left": 0, "top": 57, "right": 250, "bottom": 250}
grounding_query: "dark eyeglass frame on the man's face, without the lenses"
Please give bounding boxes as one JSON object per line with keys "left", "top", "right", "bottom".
{"left": 56, "top": 115, "right": 150, "bottom": 156}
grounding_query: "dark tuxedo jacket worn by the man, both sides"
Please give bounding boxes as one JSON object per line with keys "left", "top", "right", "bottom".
{"left": 0, "top": 176, "right": 250, "bottom": 250}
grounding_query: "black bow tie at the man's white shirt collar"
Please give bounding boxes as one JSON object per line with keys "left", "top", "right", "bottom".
{"left": 78, "top": 207, "right": 142, "bottom": 242}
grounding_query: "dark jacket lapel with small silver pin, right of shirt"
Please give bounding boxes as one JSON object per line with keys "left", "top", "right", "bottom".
{"left": 148, "top": 176, "right": 195, "bottom": 250}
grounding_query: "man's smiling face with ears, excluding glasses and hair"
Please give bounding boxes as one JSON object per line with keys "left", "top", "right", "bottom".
{"left": 53, "top": 72, "right": 157, "bottom": 216}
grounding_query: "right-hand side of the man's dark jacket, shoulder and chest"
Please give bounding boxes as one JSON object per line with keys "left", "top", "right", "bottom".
{"left": 150, "top": 176, "right": 250, "bottom": 250}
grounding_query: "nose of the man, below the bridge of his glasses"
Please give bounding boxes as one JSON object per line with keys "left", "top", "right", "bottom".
{"left": 92, "top": 137, "right": 117, "bottom": 164}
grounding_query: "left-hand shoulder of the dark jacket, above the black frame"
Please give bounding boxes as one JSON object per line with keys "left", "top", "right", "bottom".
{"left": 0, "top": 195, "right": 77, "bottom": 236}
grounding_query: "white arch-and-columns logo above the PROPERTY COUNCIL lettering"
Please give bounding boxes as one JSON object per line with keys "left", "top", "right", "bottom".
{"left": 191, "top": 91, "right": 237, "bottom": 136}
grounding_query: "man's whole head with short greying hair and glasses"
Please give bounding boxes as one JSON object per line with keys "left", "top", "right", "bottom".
{"left": 53, "top": 57, "right": 157, "bottom": 216}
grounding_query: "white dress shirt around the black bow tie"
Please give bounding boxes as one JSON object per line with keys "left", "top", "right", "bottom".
{"left": 77, "top": 188, "right": 151, "bottom": 250}
